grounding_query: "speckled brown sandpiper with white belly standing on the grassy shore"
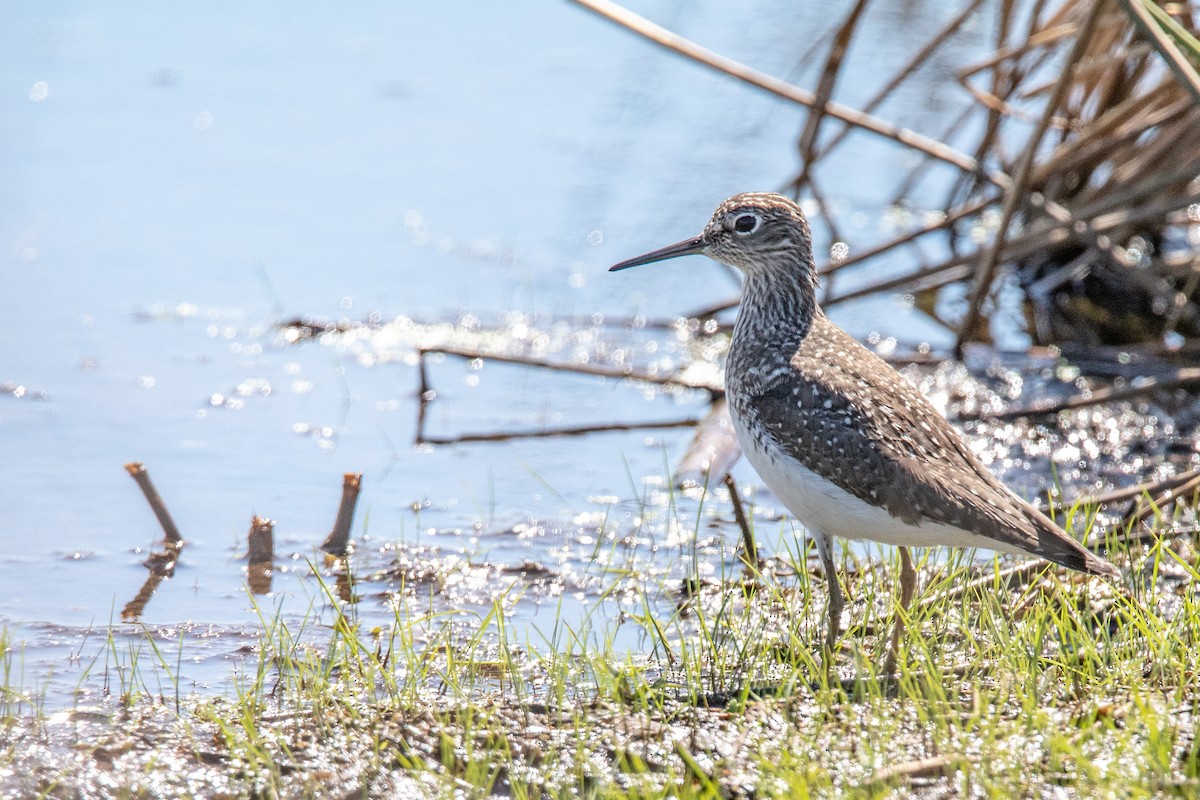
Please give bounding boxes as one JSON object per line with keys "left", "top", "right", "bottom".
{"left": 610, "top": 192, "right": 1121, "bottom": 674}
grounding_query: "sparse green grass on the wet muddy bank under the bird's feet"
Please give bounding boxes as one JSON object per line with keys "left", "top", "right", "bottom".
{"left": 2, "top": 491, "right": 1200, "bottom": 798}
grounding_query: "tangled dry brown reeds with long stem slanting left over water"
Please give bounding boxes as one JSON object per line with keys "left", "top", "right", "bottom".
{"left": 576, "top": 0, "right": 1200, "bottom": 357}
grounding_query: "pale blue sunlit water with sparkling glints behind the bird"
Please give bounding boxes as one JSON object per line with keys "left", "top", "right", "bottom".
{"left": 7, "top": 2, "right": 1190, "bottom": 704}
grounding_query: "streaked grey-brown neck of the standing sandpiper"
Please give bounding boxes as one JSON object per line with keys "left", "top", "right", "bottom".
{"left": 725, "top": 270, "right": 822, "bottom": 387}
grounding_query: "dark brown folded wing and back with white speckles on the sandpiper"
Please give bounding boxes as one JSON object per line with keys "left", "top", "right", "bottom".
{"left": 749, "top": 314, "right": 1091, "bottom": 563}
